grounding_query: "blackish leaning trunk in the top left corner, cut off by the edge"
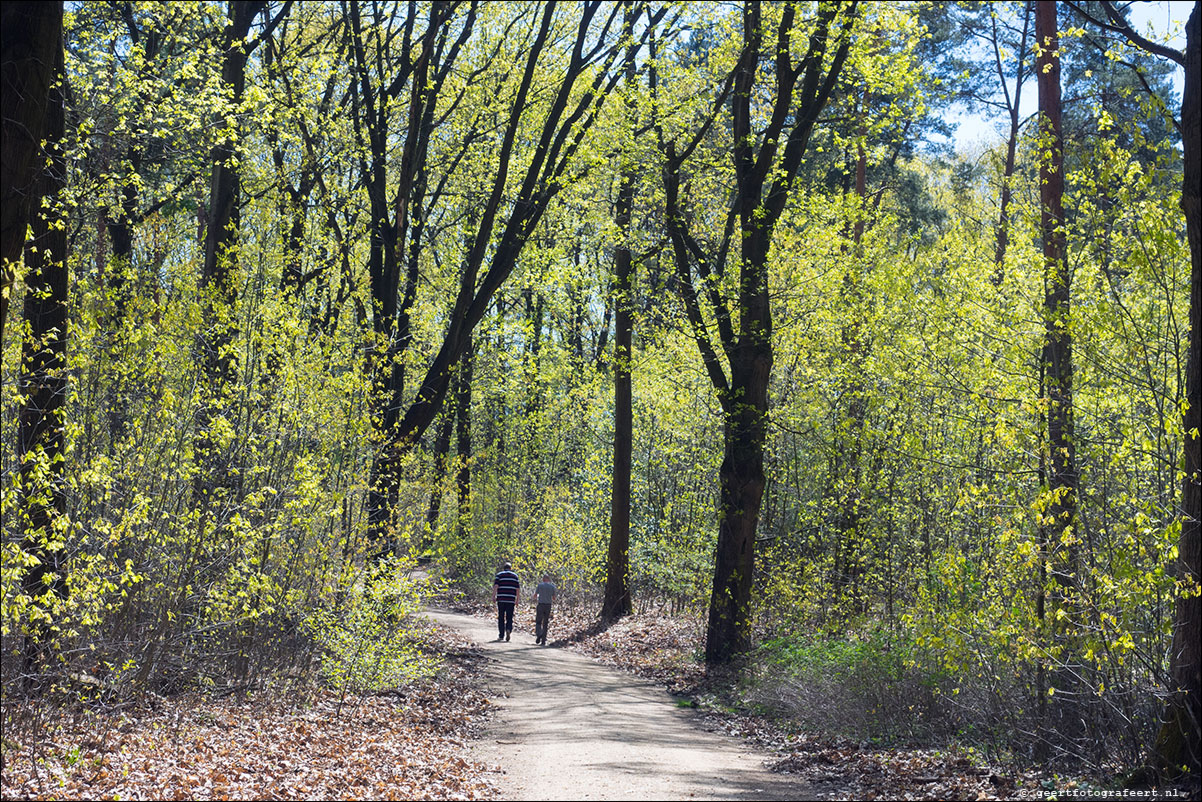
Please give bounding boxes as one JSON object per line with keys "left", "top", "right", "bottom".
{"left": 0, "top": 0, "right": 63, "bottom": 343}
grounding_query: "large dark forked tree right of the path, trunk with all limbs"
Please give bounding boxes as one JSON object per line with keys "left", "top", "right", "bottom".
{"left": 650, "top": 0, "right": 858, "bottom": 664}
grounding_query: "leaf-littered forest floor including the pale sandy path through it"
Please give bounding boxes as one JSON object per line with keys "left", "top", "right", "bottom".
{"left": 0, "top": 606, "right": 1153, "bottom": 800}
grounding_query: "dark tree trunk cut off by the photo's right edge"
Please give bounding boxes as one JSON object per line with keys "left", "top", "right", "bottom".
{"left": 1152, "top": 4, "right": 1202, "bottom": 782}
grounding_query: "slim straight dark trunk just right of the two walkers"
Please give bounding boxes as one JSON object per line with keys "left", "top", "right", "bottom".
{"left": 601, "top": 0, "right": 636, "bottom": 622}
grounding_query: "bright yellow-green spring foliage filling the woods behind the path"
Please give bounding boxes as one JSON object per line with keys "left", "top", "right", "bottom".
{"left": 0, "top": 2, "right": 1198, "bottom": 779}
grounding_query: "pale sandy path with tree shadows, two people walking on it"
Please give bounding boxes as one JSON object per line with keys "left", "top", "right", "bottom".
{"left": 427, "top": 606, "right": 816, "bottom": 800}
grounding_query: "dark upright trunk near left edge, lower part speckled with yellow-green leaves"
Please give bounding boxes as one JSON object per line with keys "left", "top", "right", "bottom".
{"left": 17, "top": 29, "right": 67, "bottom": 672}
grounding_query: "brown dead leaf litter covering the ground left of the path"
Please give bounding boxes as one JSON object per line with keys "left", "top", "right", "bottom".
{"left": 0, "top": 631, "right": 496, "bottom": 800}
